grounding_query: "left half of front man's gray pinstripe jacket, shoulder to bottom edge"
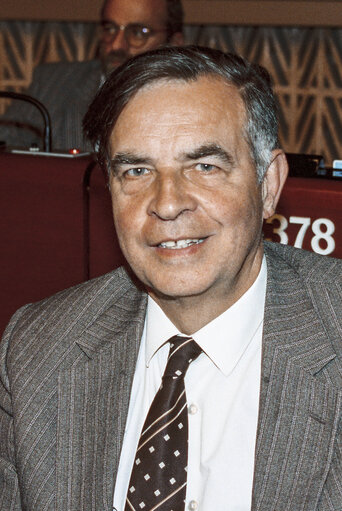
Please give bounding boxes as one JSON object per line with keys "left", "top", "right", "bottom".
{"left": 0, "top": 268, "right": 146, "bottom": 511}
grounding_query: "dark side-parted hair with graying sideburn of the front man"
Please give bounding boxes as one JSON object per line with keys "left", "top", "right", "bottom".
{"left": 83, "top": 46, "right": 278, "bottom": 182}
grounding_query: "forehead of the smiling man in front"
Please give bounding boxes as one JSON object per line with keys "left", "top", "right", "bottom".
{"left": 111, "top": 77, "right": 246, "bottom": 152}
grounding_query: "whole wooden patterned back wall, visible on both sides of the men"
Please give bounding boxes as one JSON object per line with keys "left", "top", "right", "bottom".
{"left": 0, "top": 22, "right": 342, "bottom": 164}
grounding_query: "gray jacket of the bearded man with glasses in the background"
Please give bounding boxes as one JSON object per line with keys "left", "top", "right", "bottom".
{"left": 0, "top": 60, "right": 101, "bottom": 150}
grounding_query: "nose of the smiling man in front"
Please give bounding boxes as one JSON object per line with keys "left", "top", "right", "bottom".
{"left": 148, "top": 175, "right": 197, "bottom": 220}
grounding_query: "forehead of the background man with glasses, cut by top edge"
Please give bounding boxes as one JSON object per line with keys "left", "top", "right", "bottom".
{"left": 102, "top": 0, "right": 167, "bottom": 24}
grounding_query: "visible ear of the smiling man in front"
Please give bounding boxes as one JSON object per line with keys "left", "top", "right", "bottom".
{"left": 262, "top": 149, "right": 289, "bottom": 218}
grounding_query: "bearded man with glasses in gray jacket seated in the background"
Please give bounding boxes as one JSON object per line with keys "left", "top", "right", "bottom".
{"left": 0, "top": 0, "right": 183, "bottom": 150}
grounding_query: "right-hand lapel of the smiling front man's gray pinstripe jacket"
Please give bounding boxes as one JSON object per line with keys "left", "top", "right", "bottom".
{"left": 252, "top": 246, "right": 341, "bottom": 511}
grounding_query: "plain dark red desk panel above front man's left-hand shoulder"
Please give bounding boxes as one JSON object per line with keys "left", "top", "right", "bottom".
{"left": 0, "top": 153, "right": 90, "bottom": 334}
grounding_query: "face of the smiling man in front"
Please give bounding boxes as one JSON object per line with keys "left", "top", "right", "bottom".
{"left": 110, "top": 77, "right": 280, "bottom": 312}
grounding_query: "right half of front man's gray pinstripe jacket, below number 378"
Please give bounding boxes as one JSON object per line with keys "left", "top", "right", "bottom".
{"left": 252, "top": 243, "right": 342, "bottom": 511}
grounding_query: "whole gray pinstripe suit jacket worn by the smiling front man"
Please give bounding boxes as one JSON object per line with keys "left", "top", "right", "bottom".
{"left": 0, "top": 245, "right": 342, "bottom": 511}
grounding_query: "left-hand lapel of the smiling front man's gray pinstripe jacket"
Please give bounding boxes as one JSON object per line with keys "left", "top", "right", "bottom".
{"left": 57, "top": 270, "right": 146, "bottom": 511}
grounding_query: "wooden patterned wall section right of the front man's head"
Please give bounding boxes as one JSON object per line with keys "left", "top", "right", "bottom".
{"left": 187, "top": 27, "right": 342, "bottom": 164}
